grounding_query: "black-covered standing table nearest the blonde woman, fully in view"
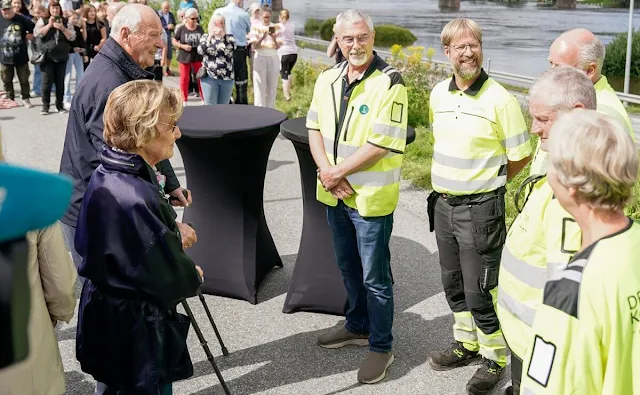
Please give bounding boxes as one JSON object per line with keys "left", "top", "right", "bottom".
{"left": 177, "top": 105, "right": 287, "bottom": 304}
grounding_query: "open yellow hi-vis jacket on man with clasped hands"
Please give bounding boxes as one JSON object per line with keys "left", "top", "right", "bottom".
{"left": 307, "top": 55, "right": 408, "bottom": 217}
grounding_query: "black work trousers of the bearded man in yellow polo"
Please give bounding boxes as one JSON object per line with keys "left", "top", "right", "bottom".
{"left": 434, "top": 192, "right": 507, "bottom": 349}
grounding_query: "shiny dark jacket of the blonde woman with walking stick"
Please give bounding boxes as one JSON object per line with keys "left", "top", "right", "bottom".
{"left": 75, "top": 146, "right": 200, "bottom": 395}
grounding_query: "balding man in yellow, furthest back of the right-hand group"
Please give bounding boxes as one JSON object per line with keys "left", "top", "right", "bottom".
{"left": 529, "top": 29, "right": 639, "bottom": 175}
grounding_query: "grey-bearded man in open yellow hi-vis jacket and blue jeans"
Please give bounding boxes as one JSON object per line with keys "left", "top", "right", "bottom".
{"left": 307, "top": 10, "right": 407, "bottom": 384}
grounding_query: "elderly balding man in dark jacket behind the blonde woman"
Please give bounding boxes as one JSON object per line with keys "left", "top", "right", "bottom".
{"left": 60, "top": 4, "right": 195, "bottom": 276}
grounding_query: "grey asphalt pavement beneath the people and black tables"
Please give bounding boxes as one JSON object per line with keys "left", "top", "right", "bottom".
{"left": 0, "top": 68, "right": 509, "bottom": 395}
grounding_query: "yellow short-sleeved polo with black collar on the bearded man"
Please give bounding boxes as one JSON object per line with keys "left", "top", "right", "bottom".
{"left": 429, "top": 70, "right": 531, "bottom": 196}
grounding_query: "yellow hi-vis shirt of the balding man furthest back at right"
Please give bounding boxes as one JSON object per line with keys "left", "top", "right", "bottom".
{"left": 529, "top": 75, "right": 638, "bottom": 175}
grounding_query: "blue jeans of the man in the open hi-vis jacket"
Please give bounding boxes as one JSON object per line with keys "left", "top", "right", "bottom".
{"left": 327, "top": 201, "right": 393, "bottom": 352}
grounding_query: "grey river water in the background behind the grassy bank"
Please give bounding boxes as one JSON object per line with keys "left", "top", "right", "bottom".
{"left": 283, "top": 0, "right": 640, "bottom": 76}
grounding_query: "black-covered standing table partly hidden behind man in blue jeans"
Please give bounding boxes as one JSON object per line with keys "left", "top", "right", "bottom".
{"left": 280, "top": 118, "right": 416, "bottom": 315}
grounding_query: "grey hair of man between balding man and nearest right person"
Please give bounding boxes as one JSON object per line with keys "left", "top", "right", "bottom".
{"left": 529, "top": 66, "right": 597, "bottom": 111}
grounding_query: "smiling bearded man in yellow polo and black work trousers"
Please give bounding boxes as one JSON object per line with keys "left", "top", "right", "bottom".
{"left": 429, "top": 19, "right": 531, "bottom": 394}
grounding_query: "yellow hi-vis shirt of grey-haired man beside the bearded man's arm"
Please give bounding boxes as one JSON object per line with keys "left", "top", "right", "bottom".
{"left": 496, "top": 177, "right": 582, "bottom": 359}
